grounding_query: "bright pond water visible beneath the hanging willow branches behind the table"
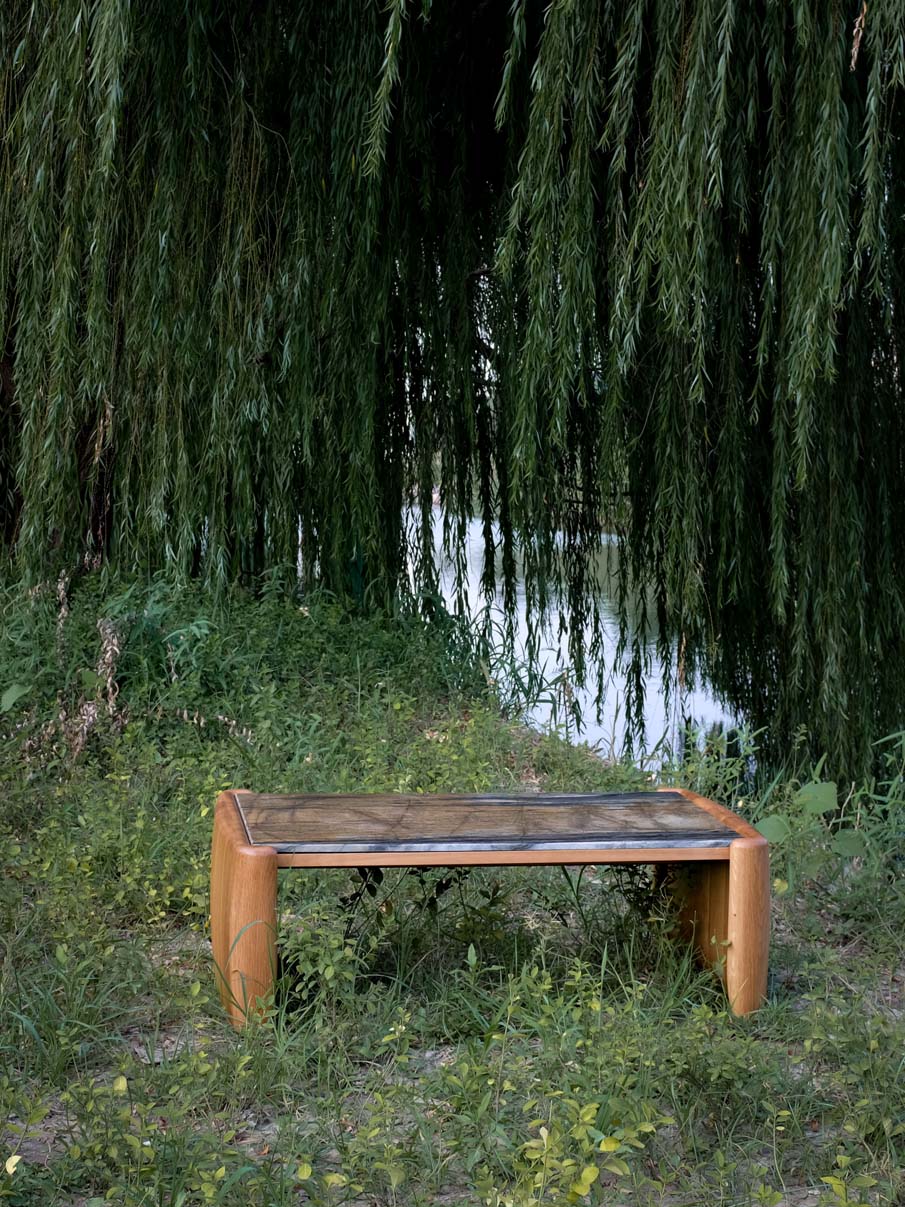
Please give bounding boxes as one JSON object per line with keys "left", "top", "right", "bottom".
{"left": 433, "top": 508, "right": 734, "bottom": 759}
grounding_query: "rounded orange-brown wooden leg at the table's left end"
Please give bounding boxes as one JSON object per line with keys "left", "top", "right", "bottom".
{"left": 210, "top": 792, "right": 276, "bottom": 1027}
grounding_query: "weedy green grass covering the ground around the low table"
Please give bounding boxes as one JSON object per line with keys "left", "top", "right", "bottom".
{"left": 0, "top": 576, "right": 905, "bottom": 1207}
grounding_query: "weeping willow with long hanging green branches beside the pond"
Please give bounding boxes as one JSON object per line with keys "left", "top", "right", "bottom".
{"left": 0, "top": 0, "right": 905, "bottom": 770}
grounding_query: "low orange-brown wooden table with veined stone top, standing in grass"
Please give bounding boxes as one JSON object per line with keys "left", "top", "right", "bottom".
{"left": 211, "top": 789, "right": 770, "bottom": 1027}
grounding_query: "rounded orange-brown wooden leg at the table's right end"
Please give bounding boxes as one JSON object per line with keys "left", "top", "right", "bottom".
{"left": 673, "top": 838, "right": 770, "bottom": 1014}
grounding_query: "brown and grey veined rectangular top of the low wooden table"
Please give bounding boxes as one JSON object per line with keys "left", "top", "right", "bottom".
{"left": 235, "top": 791, "right": 754, "bottom": 864}
